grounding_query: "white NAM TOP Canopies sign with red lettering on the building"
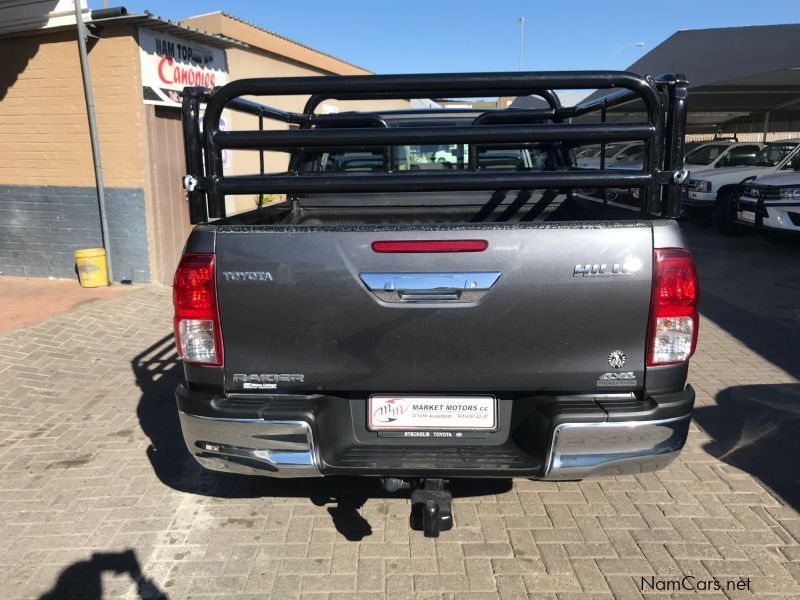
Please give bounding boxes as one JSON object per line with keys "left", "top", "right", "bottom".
{"left": 139, "top": 27, "right": 228, "bottom": 106}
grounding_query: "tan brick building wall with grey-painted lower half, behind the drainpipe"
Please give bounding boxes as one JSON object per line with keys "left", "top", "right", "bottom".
{"left": 0, "top": 26, "right": 151, "bottom": 281}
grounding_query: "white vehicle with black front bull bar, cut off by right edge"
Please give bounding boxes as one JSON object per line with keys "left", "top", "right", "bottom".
{"left": 734, "top": 168, "right": 800, "bottom": 233}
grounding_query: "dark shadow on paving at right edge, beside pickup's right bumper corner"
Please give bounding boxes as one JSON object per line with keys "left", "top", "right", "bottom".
{"left": 694, "top": 384, "right": 800, "bottom": 510}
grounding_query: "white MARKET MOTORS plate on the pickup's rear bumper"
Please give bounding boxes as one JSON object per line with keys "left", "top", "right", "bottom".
{"left": 367, "top": 394, "right": 496, "bottom": 431}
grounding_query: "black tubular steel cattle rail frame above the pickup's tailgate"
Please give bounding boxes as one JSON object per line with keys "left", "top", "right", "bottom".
{"left": 182, "top": 71, "right": 687, "bottom": 223}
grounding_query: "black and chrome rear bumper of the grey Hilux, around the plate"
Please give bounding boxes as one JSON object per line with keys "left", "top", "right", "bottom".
{"left": 177, "top": 386, "right": 694, "bottom": 480}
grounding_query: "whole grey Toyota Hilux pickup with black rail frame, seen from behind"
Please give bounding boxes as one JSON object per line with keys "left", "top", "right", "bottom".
{"left": 174, "top": 71, "right": 698, "bottom": 535}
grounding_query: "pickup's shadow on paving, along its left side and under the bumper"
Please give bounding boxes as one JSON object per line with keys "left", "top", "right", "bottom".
{"left": 131, "top": 334, "right": 511, "bottom": 541}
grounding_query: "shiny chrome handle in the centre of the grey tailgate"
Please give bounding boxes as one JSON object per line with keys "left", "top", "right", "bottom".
{"left": 359, "top": 272, "right": 500, "bottom": 303}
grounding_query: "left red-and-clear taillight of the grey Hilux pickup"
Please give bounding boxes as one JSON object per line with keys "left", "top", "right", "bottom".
{"left": 172, "top": 254, "right": 222, "bottom": 365}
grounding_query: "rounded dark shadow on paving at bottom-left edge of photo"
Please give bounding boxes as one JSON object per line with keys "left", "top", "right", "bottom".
{"left": 39, "top": 550, "right": 167, "bottom": 600}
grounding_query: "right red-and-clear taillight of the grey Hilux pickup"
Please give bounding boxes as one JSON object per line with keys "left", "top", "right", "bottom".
{"left": 647, "top": 248, "right": 699, "bottom": 366}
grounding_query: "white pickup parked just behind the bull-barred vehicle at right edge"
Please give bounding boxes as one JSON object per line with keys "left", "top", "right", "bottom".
{"left": 683, "top": 139, "right": 800, "bottom": 233}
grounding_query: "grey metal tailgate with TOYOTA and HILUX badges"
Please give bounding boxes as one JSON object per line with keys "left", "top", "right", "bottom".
{"left": 216, "top": 222, "right": 653, "bottom": 393}
